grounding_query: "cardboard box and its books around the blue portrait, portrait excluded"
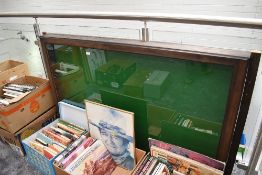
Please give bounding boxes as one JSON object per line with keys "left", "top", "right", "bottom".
{"left": 54, "top": 148, "right": 146, "bottom": 175}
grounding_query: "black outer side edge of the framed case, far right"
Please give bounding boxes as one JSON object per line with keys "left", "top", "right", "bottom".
{"left": 224, "top": 52, "right": 261, "bottom": 175}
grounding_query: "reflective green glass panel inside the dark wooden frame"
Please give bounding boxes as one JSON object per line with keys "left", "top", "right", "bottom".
{"left": 47, "top": 45, "right": 232, "bottom": 157}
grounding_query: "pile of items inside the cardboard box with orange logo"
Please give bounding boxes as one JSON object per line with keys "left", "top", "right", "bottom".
{"left": 0, "top": 83, "right": 36, "bottom": 106}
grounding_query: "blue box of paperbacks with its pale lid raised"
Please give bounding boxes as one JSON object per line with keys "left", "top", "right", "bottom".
{"left": 22, "top": 102, "right": 88, "bottom": 175}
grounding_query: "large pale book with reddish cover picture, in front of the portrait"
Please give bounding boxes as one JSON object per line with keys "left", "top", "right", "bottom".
{"left": 65, "top": 140, "right": 117, "bottom": 175}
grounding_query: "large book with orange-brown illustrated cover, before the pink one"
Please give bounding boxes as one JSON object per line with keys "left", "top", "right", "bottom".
{"left": 150, "top": 146, "right": 223, "bottom": 175}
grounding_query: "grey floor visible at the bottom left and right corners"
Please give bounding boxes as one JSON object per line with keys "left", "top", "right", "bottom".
{"left": 0, "top": 141, "right": 245, "bottom": 175}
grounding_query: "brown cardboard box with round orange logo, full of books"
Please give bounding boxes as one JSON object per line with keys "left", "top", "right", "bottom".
{"left": 0, "top": 76, "right": 55, "bottom": 133}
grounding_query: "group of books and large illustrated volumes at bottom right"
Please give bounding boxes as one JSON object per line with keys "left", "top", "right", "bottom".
{"left": 134, "top": 139, "right": 225, "bottom": 175}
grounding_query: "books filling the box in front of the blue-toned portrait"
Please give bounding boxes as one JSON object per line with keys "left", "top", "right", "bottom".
{"left": 54, "top": 137, "right": 117, "bottom": 175}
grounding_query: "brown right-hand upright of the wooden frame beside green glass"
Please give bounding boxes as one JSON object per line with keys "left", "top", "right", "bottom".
{"left": 217, "top": 60, "right": 247, "bottom": 162}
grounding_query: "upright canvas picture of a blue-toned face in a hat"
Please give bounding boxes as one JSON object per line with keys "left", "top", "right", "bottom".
{"left": 85, "top": 100, "right": 135, "bottom": 170}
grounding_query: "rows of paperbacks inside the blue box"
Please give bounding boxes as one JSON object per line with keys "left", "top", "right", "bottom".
{"left": 30, "top": 120, "right": 86, "bottom": 159}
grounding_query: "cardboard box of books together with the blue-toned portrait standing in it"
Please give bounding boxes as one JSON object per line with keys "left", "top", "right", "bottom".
{"left": 54, "top": 100, "right": 145, "bottom": 175}
